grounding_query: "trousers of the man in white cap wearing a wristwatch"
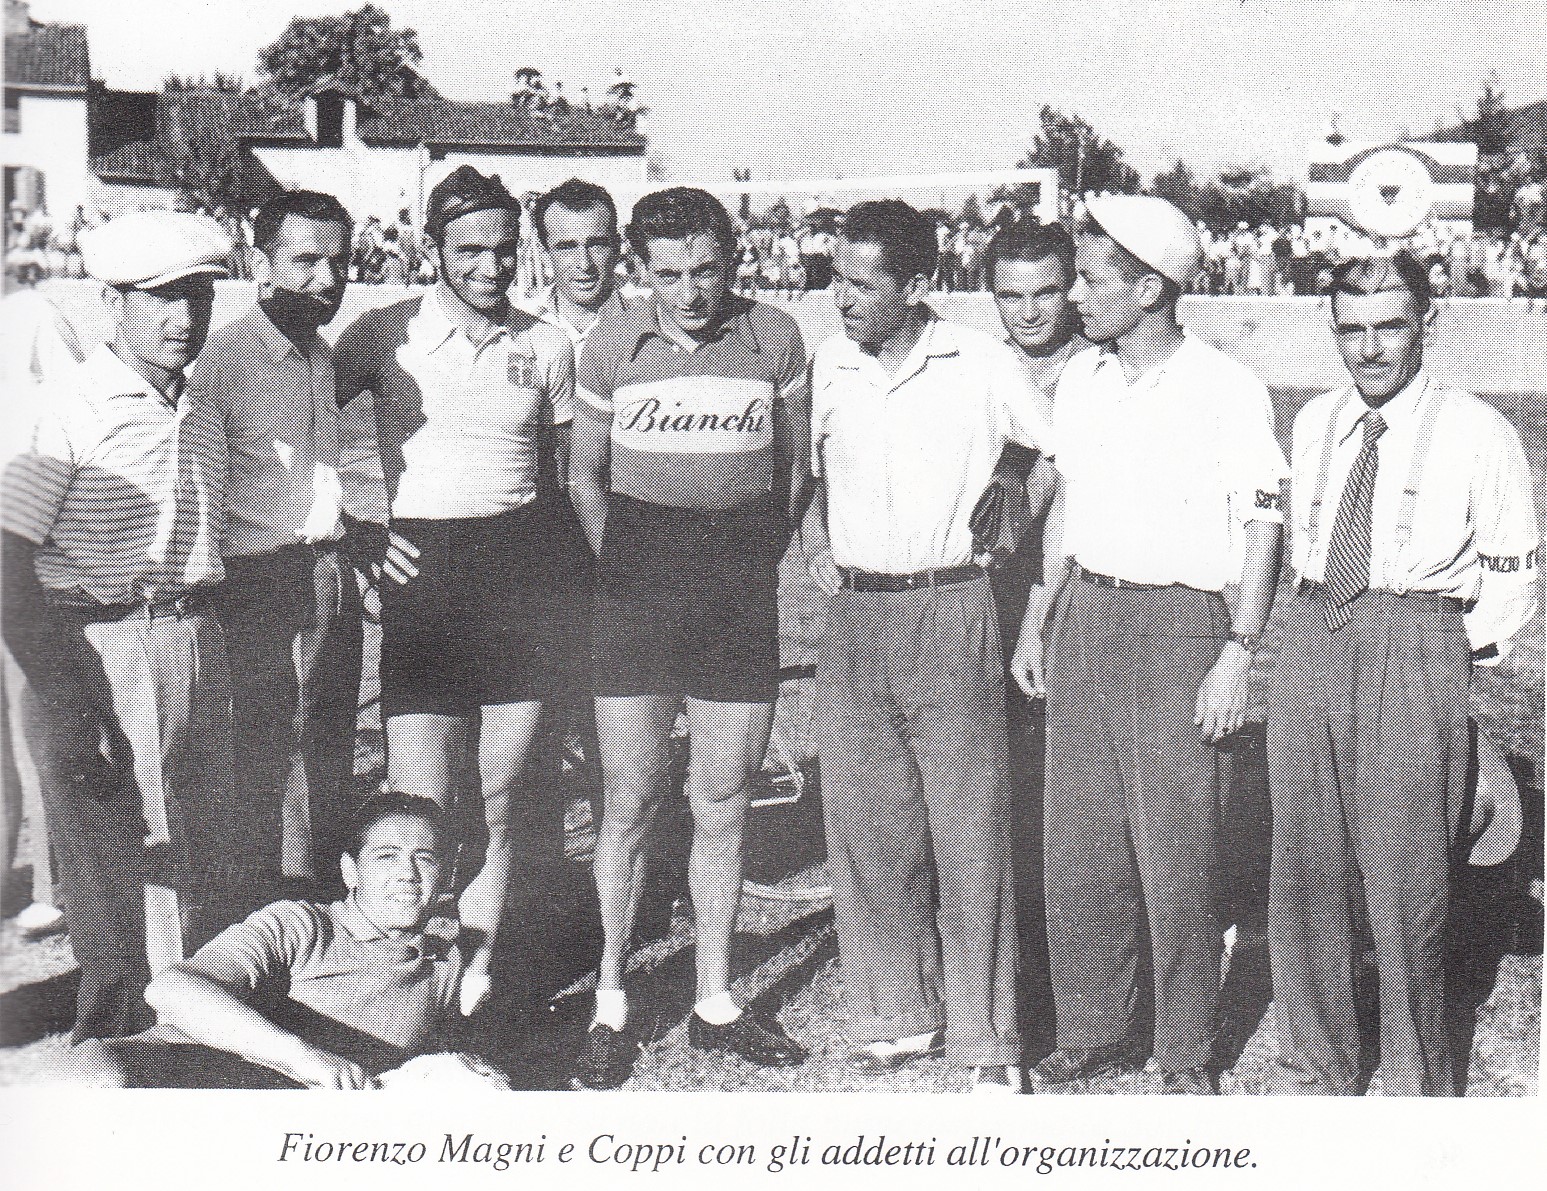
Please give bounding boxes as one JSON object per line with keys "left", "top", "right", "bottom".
{"left": 1043, "top": 578, "right": 1230, "bottom": 1070}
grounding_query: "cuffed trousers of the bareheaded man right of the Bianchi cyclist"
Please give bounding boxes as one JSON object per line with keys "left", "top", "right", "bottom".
{"left": 817, "top": 578, "right": 1021, "bottom": 1066}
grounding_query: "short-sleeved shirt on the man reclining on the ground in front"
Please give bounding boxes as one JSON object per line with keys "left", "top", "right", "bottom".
{"left": 179, "top": 902, "right": 463, "bottom": 1069}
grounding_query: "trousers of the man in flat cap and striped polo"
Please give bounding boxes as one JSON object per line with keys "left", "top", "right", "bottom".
{"left": 26, "top": 613, "right": 232, "bottom": 1041}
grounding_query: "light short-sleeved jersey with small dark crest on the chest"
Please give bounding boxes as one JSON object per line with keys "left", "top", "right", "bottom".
{"left": 333, "top": 291, "right": 574, "bottom": 520}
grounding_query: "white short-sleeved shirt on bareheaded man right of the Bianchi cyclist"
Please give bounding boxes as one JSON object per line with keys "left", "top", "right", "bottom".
{"left": 811, "top": 317, "right": 1052, "bottom": 574}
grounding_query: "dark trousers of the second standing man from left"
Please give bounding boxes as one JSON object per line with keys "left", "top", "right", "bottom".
{"left": 221, "top": 544, "right": 362, "bottom": 903}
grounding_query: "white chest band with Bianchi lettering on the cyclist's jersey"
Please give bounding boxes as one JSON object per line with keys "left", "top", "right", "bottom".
{"left": 613, "top": 376, "right": 774, "bottom": 455}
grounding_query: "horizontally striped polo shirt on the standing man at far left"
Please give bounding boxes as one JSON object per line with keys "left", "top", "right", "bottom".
{"left": 5, "top": 345, "right": 227, "bottom": 603}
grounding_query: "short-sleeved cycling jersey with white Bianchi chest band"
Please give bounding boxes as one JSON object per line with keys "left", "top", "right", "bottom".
{"left": 575, "top": 297, "right": 806, "bottom": 509}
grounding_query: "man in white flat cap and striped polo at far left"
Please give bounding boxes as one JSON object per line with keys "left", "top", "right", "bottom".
{"left": 3, "top": 212, "right": 232, "bottom": 1041}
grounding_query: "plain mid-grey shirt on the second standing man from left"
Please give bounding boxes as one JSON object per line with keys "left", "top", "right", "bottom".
{"left": 184, "top": 306, "right": 339, "bottom": 558}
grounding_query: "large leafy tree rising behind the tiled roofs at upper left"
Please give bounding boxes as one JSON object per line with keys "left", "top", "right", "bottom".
{"left": 258, "top": 5, "right": 435, "bottom": 99}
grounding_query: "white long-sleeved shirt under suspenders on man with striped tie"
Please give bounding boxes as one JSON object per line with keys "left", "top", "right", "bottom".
{"left": 1292, "top": 370, "right": 1541, "bottom": 657}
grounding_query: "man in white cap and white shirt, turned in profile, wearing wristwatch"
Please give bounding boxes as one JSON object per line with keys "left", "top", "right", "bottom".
{"left": 1012, "top": 195, "right": 1287, "bottom": 1094}
